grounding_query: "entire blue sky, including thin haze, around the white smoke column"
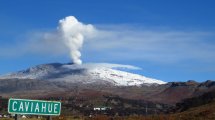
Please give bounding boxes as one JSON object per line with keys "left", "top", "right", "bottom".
{"left": 0, "top": 0, "right": 215, "bottom": 81}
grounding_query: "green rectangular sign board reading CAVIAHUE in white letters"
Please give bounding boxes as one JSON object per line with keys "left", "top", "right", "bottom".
{"left": 8, "top": 98, "right": 61, "bottom": 119}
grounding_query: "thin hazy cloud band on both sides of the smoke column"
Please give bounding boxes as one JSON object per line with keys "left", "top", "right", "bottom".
{"left": 0, "top": 25, "right": 215, "bottom": 63}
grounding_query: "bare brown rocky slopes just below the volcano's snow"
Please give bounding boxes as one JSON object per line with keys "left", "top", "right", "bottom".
{"left": 0, "top": 79, "right": 215, "bottom": 104}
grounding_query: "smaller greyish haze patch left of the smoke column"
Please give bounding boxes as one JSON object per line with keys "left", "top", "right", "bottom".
{"left": 0, "top": 32, "right": 67, "bottom": 57}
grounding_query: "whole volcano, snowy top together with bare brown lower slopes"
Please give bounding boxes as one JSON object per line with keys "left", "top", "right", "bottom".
{"left": 0, "top": 63, "right": 215, "bottom": 104}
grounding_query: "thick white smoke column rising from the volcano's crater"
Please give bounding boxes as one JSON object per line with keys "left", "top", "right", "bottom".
{"left": 58, "top": 16, "right": 95, "bottom": 64}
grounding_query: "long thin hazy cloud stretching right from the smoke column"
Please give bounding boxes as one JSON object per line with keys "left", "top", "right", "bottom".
{"left": 84, "top": 27, "right": 215, "bottom": 63}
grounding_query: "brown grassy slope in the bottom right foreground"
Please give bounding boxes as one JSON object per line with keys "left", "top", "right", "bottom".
{"left": 86, "top": 101, "right": 215, "bottom": 120}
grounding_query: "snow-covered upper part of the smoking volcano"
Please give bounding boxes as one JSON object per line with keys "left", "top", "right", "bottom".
{"left": 0, "top": 63, "right": 165, "bottom": 86}
